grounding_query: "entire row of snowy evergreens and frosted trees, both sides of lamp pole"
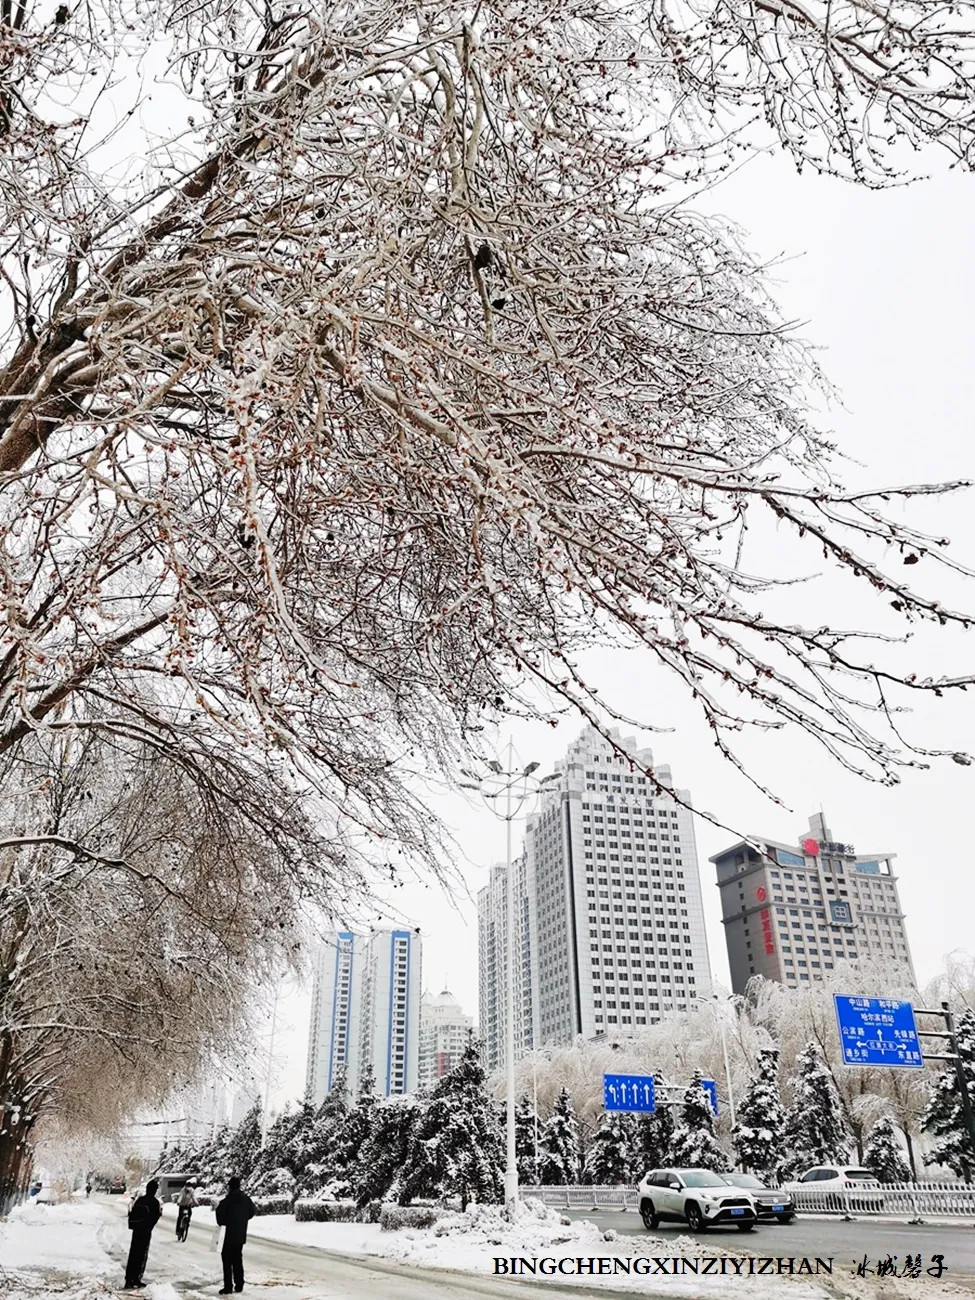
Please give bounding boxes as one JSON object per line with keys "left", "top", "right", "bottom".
{"left": 156, "top": 971, "right": 975, "bottom": 1209}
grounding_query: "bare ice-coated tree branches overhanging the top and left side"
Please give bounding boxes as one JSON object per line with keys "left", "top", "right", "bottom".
{"left": 0, "top": 0, "right": 975, "bottom": 1199}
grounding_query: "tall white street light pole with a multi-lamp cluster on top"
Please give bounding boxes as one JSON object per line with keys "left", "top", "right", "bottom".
{"left": 462, "top": 741, "right": 558, "bottom": 1221}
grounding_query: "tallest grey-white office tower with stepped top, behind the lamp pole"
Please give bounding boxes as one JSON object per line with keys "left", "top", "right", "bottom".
{"left": 478, "top": 728, "right": 711, "bottom": 1069}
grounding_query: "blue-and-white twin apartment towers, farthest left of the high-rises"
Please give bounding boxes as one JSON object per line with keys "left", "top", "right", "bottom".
{"left": 306, "top": 930, "right": 421, "bottom": 1105}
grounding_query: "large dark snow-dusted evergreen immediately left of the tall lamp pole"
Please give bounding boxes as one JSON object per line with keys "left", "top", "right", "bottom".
{"left": 400, "top": 1043, "right": 504, "bottom": 1209}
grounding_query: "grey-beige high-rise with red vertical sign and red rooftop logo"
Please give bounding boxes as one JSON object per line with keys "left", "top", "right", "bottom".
{"left": 711, "top": 813, "right": 914, "bottom": 993}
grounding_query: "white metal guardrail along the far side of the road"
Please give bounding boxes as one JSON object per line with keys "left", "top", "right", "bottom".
{"left": 521, "top": 1183, "right": 975, "bottom": 1218}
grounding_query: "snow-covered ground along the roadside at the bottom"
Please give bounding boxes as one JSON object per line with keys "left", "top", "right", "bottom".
{"left": 0, "top": 1201, "right": 972, "bottom": 1300}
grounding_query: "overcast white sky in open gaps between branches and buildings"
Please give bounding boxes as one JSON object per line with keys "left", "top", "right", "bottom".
{"left": 257, "top": 149, "right": 975, "bottom": 1105}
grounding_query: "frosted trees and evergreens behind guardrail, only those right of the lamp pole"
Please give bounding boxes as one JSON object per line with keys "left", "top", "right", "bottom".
{"left": 491, "top": 962, "right": 975, "bottom": 1182}
